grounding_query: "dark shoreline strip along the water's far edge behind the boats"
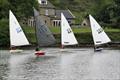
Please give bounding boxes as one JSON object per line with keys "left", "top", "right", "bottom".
{"left": 0, "top": 43, "right": 120, "bottom": 50}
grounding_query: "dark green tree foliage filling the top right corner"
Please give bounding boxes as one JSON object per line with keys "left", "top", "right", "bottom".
{"left": 98, "top": 0, "right": 120, "bottom": 28}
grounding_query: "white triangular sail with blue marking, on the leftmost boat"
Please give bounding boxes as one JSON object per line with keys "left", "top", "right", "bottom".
{"left": 9, "top": 11, "right": 29, "bottom": 46}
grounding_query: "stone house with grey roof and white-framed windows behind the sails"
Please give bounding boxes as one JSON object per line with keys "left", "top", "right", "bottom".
{"left": 28, "top": 0, "right": 75, "bottom": 27}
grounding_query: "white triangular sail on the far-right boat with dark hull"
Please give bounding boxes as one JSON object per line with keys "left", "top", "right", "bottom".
{"left": 89, "top": 15, "right": 111, "bottom": 45}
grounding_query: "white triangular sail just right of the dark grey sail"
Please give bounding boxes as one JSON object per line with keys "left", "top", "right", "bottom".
{"left": 61, "top": 13, "right": 78, "bottom": 45}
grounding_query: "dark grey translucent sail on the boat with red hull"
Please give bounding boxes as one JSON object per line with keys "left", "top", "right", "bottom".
{"left": 34, "top": 8, "right": 56, "bottom": 46}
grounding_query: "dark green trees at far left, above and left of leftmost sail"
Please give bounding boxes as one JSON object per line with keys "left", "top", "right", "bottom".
{"left": 0, "top": 0, "right": 38, "bottom": 46}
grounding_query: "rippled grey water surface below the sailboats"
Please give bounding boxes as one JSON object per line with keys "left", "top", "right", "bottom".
{"left": 0, "top": 48, "right": 120, "bottom": 80}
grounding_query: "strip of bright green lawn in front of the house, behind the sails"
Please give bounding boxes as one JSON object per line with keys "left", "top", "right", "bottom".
{"left": 23, "top": 27, "right": 120, "bottom": 34}
